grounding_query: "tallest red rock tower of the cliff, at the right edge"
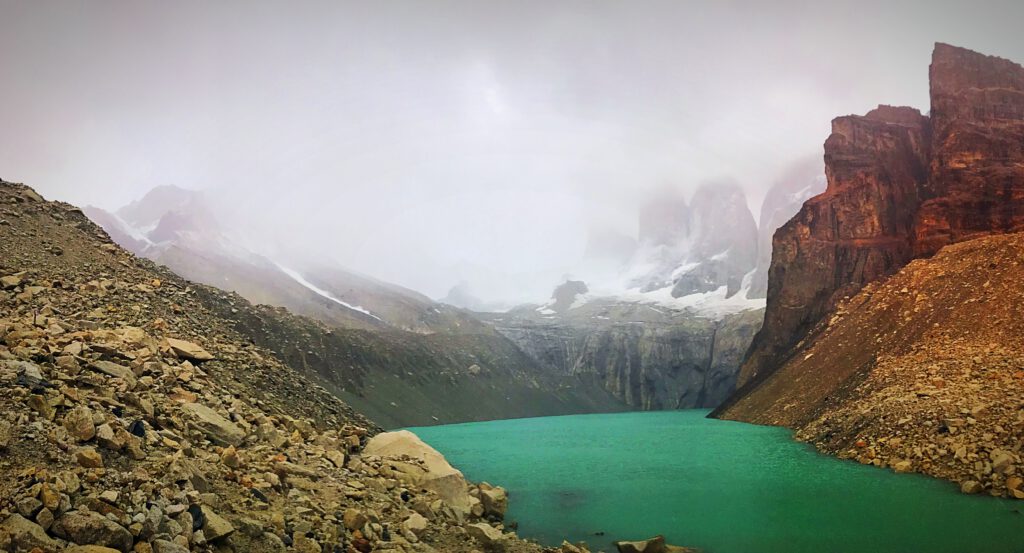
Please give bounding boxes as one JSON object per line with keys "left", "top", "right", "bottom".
{"left": 914, "top": 44, "right": 1024, "bottom": 256}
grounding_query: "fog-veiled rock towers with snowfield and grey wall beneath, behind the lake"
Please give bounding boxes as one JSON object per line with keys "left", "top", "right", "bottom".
{"left": 480, "top": 183, "right": 763, "bottom": 410}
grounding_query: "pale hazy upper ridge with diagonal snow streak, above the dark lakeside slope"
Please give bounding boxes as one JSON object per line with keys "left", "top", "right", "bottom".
{"left": 83, "top": 186, "right": 482, "bottom": 333}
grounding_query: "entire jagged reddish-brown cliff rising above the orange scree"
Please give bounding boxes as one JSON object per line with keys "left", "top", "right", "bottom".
{"left": 720, "top": 44, "right": 1024, "bottom": 405}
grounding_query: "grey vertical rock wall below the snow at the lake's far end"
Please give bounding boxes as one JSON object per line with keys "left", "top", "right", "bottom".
{"left": 490, "top": 299, "right": 763, "bottom": 410}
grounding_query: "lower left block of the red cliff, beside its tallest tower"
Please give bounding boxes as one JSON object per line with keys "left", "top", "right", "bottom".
{"left": 740, "top": 107, "right": 929, "bottom": 383}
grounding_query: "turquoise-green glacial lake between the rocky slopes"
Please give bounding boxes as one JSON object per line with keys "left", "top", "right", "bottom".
{"left": 412, "top": 411, "right": 1024, "bottom": 553}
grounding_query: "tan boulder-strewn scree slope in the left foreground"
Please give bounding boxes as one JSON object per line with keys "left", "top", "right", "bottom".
{"left": 0, "top": 181, "right": 602, "bottom": 553}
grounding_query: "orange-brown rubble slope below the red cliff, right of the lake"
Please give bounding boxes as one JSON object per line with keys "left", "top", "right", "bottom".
{"left": 728, "top": 233, "right": 1024, "bottom": 499}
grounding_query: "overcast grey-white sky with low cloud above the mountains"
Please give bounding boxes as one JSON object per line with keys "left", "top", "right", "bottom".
{"left": 0, "top": 0, "right": 1024, "bottom": 303}
